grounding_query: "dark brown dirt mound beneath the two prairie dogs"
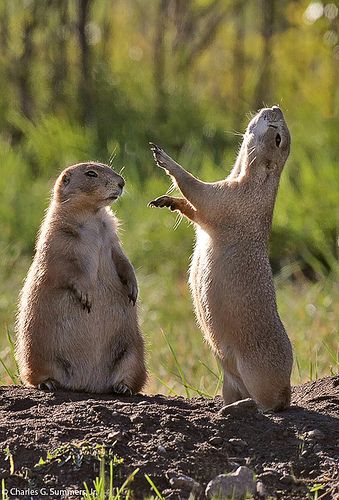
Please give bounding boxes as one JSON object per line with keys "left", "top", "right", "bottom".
{"left": 0, "top": 376, "right": 339, "bottom": 499}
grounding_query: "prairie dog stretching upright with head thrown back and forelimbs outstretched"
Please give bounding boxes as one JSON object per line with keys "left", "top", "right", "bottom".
{"left": 150, "top": 106, "right": 293, "bottom": 411}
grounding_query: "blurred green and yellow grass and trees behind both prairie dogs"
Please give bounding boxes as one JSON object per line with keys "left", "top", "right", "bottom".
{"left": 0, "top": 0, "right": 339, "bottom": 395}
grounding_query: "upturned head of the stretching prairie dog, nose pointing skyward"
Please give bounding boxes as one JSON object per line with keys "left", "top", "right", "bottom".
{"left": 237, "top": 106, "right": 291, "bottom": 182}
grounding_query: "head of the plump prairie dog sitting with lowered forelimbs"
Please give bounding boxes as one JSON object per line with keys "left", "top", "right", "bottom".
{"left": 53, "top": 162, "right": 125, "bottom": 209}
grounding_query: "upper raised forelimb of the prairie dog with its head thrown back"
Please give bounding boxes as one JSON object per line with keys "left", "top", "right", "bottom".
{"left": 150, "top": 143, "right": 212, "bottom": 211}
